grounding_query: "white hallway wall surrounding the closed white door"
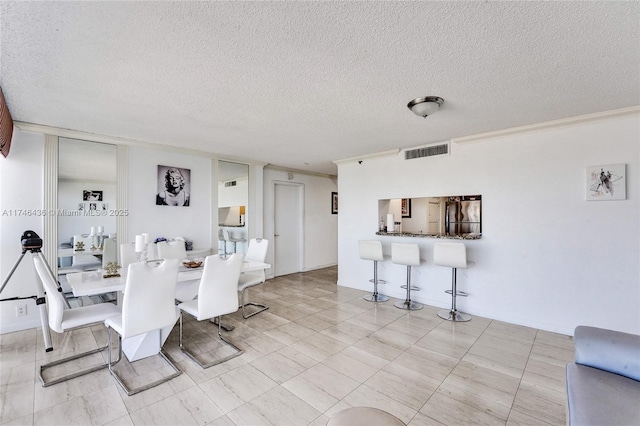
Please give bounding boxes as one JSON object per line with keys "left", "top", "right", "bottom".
{"left": 256, "top": 168, "right": 342, "bottom": 274}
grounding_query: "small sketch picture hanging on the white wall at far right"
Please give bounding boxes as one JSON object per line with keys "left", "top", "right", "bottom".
{"left": 587, "top": 164, "right": 627, "bottom": 201}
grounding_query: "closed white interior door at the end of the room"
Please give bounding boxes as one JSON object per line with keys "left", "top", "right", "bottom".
{"left": 273, "top": 183, "right": 303, "bottom": 277}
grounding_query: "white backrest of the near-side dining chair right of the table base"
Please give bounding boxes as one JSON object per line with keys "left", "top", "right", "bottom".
{"left": 197, "top": 254, "right": 244, "bottom": 321}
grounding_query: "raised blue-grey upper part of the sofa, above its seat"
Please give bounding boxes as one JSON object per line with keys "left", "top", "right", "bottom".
{"left": 574, "top": 325, "right": 640, "bottom": 380}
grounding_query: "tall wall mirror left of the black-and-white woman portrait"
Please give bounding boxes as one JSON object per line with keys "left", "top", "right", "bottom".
{"left": 57, "top": 138, "right": 117, "bottom": 266}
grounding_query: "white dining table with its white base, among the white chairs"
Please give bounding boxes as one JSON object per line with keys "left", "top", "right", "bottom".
{"left": 67, "top": 260, "right": 271, "bottom": 362}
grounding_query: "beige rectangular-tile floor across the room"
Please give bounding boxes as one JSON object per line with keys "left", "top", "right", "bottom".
{"left": 0, "top": 268, "right": 573, "bottom": 425}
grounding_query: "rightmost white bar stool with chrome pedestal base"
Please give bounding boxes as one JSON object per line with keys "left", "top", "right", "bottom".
{"left": 433, "top": 243, "right": 472, "bottom": 322}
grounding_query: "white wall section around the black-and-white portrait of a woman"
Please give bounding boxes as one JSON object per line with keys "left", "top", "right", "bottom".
{"left": 127, "top": 146, "right": 212, "bottom": 249}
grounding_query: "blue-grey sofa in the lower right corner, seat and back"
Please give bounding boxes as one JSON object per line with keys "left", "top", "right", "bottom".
{"left": 567, "top": 326, "right": 640, "bottom": 426}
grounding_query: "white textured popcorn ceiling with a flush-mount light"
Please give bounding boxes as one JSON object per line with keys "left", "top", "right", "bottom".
{"left": 0, "top": 1, "right": 640, "bottom": 174}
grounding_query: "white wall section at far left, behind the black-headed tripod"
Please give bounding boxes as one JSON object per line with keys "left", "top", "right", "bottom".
{"left": 0, "top": 129, "right": 45, "bottom": 333}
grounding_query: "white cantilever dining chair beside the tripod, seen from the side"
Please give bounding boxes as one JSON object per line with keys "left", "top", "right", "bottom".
{"left": 33, "top": 257, "right": 120, "bottom": 387}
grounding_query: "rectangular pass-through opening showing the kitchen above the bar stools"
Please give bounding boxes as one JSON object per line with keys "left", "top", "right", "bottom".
{"left": 378, "top": 195, "right": 482, "bottom": 238}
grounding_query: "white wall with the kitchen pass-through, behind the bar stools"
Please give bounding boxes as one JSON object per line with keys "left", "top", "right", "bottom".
{"left": 338, "top": 114, "right": 640, "bottom": 334}
